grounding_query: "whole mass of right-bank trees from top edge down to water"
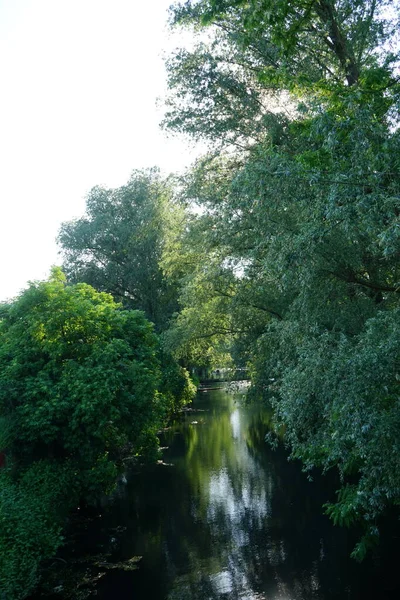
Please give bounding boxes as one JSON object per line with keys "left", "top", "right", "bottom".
{"left": 165, "top": 0, "right": 400, "bottom": 559}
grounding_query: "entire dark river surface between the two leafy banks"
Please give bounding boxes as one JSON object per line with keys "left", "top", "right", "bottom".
{"left": 66, "top": 390, "right": 399, "bottom": 600}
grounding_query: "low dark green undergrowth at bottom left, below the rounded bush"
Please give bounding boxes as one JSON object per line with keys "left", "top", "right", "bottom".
{"left": 0, "top": 461, "right": 77, "bottom": 600}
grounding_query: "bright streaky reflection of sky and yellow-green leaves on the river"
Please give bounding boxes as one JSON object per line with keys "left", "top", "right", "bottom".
{"left": 159, "top": 393, "right": 322, "bottom": 600}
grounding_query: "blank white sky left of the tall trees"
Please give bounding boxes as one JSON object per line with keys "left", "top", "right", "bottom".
{"left": 0, "top": 0, "right": 197, "bottom": 301}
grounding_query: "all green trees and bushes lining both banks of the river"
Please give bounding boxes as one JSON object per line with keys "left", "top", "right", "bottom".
{"left": 0, "top": 0, "right": 400, "bottom": 600}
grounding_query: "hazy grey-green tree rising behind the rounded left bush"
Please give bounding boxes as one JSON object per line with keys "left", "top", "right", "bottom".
{"left": 58, "top": 169, "right": 182, "bottom": 330}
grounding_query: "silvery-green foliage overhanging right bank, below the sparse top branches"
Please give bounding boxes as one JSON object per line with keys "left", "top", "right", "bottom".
{"left": 166, "top": 106, "right": 400, "bottom": 556}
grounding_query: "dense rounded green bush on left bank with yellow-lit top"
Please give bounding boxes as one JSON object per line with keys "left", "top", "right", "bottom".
{"left": 0, "top": 269, "right": 172, "bottom": 600}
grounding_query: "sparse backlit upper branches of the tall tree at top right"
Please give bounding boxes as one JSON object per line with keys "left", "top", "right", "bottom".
{"left": 163, "top": 0, "right": 399, "bottom": 150}
